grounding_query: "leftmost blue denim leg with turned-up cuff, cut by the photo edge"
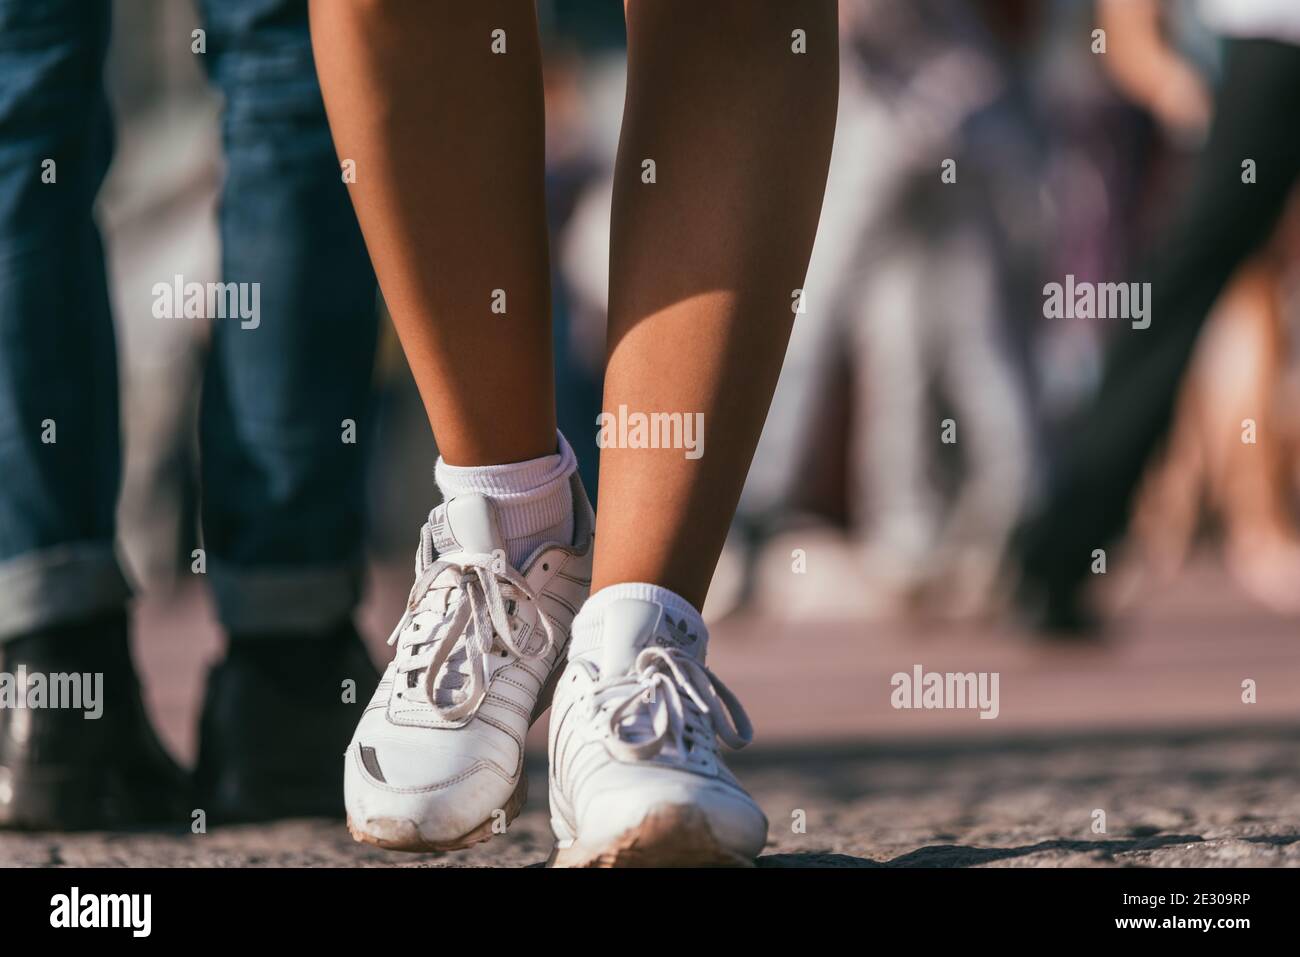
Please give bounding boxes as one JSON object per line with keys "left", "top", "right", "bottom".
{"left": 0, "top": 0, "right": 129, "bottom": 638}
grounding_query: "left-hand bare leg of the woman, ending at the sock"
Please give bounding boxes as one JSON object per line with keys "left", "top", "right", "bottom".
{"left": 311, "top": 0, "right": 555, "bottom": 465}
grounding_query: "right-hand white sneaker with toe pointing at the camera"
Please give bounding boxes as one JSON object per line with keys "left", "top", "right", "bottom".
{"left": 549, "top": 598, "right": 767, "bottom": 867}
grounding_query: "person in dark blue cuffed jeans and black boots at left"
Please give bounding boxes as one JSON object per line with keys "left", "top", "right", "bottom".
{"left": 0, "top": 0, "right": 376, "bottom": 828}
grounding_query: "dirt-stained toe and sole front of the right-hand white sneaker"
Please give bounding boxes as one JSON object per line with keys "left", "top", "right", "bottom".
{"left": 546, "top": 805, "right": 754, "bottom": 867}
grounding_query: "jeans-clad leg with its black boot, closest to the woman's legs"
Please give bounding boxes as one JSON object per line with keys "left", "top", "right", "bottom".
{"left": 189, "top": 0, "right": 378, "bottom": 819}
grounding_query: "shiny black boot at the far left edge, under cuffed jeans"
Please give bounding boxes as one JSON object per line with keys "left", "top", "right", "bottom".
{"left": 0, "top": 612, "right": 190, "bottom": 831}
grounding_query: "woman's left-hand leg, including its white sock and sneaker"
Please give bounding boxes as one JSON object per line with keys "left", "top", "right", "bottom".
{"left": 311, "top": 0, "right": 592, "bottom": 852}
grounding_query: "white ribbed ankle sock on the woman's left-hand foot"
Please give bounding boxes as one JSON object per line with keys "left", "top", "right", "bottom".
{"left": 433, "top": 432, "right": 577, "bottom": 568}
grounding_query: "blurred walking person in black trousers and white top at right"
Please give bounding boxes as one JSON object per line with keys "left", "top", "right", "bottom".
{"left": 1015, "top": 0, "right": 1300, "bottom": 635}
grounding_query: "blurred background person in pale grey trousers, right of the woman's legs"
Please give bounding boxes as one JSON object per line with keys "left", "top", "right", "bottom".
{"left": 836, "top": 0, "right": 1043, "bottom": 616}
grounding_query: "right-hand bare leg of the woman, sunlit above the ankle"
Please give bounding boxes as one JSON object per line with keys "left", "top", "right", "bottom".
{"left": 592, "top": 0, "right": 839, "bottom": 607}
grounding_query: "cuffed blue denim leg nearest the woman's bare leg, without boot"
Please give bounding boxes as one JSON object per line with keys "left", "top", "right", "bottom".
{"left": 192, "top": 0, "right": 377, "bottom": 635}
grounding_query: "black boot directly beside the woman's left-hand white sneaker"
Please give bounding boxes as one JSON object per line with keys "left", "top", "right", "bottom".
{"left": 195, "top": 622, "right": 378, "bottom": 823}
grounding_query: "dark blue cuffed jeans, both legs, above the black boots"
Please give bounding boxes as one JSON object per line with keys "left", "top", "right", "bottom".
{"left": 0, "top": 0, "right": 377, "bottom": 638}
